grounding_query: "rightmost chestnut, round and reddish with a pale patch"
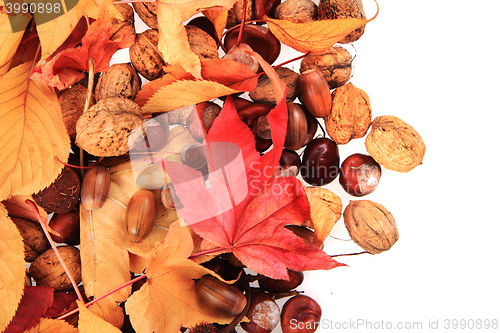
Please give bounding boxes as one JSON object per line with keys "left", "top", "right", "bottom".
{"left": 339, "top": 154, "right": 382, "bottom": 197}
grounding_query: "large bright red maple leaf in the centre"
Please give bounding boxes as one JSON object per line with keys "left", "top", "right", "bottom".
{"left": 160, "top": 53, "right": 342, "bottom": 279}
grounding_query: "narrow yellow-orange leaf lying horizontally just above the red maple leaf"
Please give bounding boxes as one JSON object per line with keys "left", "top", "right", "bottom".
{"left": 142, "top": 80, "right": 239, "bottom": 113}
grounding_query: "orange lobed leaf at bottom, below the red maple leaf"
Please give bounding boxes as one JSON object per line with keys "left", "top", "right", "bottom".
{"left": 125, "top": 222, "right": 232, "bottom": 333}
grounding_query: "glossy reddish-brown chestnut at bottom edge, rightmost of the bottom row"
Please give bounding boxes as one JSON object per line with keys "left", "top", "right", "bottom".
{"left": 281, "top": 295, "right": 321, "bottom": 333}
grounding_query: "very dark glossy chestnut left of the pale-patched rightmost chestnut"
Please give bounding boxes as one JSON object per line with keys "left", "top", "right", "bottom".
{"left": 300, "top": 138, "right": 340, "bottom": 186}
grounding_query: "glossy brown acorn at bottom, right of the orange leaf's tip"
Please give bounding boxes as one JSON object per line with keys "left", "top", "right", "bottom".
{"left": 195, "top": 275, "right": 247, "bottom": 316}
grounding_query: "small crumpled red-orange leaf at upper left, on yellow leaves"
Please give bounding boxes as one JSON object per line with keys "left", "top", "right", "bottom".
{"left": 31, "top": 13, "right": 135, "bottom": 90}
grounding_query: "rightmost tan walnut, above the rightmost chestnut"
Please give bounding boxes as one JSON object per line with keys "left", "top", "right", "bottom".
{"left": 365, "top": 116, "right": 425, "bottom": 172}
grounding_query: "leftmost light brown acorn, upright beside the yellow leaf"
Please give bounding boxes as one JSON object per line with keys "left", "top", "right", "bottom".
{"left": 81, "top": 165, "right": 111, "bottom": 210}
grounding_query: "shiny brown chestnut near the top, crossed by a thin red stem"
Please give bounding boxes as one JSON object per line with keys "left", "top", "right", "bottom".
{"left": 224, "top": 24, "right": 281, "bottom": 64}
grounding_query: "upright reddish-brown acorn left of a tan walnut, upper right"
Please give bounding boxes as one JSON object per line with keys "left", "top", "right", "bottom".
{"left": 299, "top": 68, "right": 332, "bottom": 118}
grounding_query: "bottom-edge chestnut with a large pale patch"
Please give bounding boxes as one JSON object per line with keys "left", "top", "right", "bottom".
{"left": 240, "top": 290, "right": 280, "bottom": 333}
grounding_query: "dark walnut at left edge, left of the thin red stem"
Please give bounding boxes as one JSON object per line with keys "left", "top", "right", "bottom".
{"left": 10, "top": 216, "right": 50, "bottom": 262}
